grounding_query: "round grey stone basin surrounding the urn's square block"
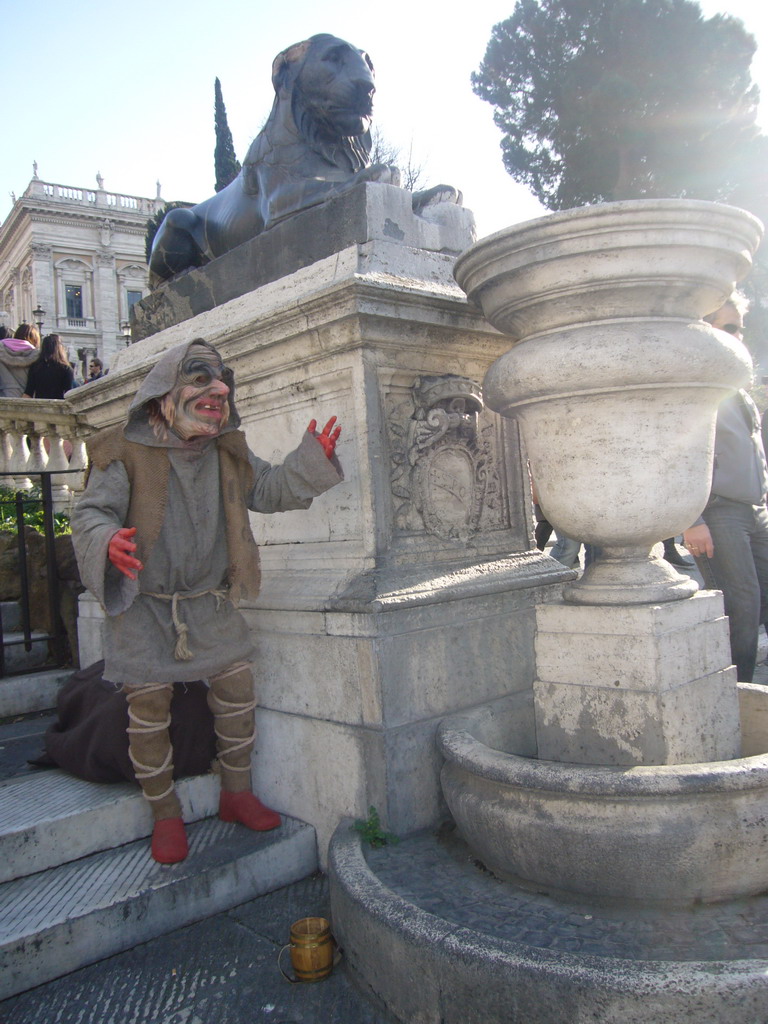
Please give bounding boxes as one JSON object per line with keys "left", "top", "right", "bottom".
{"left": 438, "top": 684, "right": 768, "bottom": 903}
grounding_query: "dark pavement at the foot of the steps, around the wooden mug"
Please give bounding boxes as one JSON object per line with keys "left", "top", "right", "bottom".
{"left": 0, "top": 874, "right": 392, "bottom": 1024}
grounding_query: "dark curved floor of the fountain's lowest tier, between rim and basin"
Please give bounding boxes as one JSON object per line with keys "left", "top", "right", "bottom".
{"left": 368, "top": 826, "right": 768, "bottom": 962}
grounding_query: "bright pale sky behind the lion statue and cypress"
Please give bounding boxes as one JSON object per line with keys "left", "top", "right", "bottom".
{"left": 0, "top": 0, "right": 768, "bottom": 238}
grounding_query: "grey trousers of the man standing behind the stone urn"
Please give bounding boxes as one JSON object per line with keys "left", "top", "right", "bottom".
{"left": 697, "top": 499, "right": 760, "bottom": 683}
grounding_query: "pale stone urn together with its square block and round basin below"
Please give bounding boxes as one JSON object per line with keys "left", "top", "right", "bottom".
{"left": 438, "top": 200, "right": 768, "bottom": 902}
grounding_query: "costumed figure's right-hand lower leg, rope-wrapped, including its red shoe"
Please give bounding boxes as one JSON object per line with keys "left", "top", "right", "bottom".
{"left": 208, "top": 664, "right": 281, "bottom": 831}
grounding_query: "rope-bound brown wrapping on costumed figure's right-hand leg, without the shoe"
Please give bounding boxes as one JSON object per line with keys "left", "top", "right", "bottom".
{"left": 208, "top": 665, "right": 256, "bottom": 793}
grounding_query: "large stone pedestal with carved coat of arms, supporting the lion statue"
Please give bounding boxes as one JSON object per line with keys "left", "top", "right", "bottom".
{"left": 71, "top": 184, "right": 573, "bottom": 858}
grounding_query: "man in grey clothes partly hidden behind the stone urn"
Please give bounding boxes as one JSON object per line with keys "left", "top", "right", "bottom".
{"left": 683, "top": 293, "right": 768, "bottom": 683}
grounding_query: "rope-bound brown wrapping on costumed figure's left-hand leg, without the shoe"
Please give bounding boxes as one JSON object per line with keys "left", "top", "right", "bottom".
{"left": 125, "top": 683, "right": 181, "bottom": 821}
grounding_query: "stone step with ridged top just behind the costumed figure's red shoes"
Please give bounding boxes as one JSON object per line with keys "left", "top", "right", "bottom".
{"left": 0, "top": 769, "right": 219, "bottom": 882}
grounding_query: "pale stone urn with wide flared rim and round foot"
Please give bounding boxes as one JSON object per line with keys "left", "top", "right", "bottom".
{"left": 454, "top": 200, "right": 761, "bottom": 604}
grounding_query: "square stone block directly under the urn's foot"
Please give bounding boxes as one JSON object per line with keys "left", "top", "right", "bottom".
{"left": 534, "top": 592, "right": 741, "bottom": 765}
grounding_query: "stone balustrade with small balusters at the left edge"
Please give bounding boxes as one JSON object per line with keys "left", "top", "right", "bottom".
{"left": 0, "top": 398, "right": 93, "bottom": 512}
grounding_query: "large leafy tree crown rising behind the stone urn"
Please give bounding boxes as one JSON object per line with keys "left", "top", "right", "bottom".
{"left": 472, "top": 0, "right": 765, "bottom": 210}
